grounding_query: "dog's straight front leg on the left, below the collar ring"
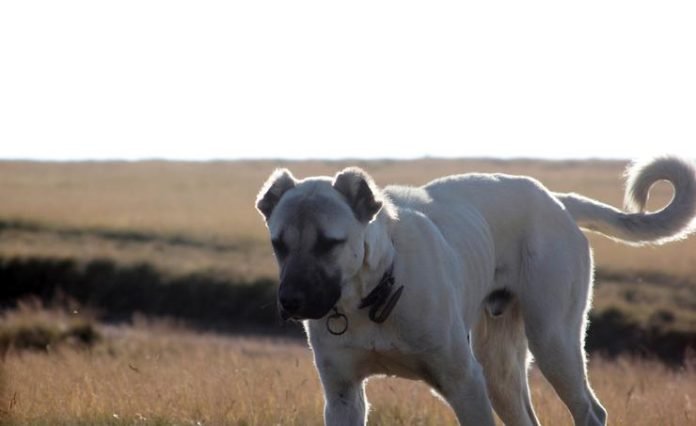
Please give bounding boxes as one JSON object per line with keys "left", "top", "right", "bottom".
{"left": 315, "top": 355, "right": 367, "bottom": 426}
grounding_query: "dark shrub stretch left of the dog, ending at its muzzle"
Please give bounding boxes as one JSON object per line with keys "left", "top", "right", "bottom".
{"left": 0, "top": 258, "right": 298, "bottom": 334}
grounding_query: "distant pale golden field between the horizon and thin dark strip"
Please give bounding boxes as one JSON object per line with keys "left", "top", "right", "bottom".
{"left": 0, "top": 159, "right": 696, "bottom": 279}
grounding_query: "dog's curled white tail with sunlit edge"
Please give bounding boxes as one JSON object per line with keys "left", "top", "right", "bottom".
{"left": 554, "top": 156, "right": 696, "bottom": 245}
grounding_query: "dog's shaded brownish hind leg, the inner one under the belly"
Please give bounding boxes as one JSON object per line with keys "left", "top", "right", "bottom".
{"left": 472, "top": 299, "right": 539, "bottom": 426}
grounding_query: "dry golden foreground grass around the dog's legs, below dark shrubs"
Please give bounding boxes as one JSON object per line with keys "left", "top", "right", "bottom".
{"left": 0, "top": 325, "right": 696, "bottom": 426}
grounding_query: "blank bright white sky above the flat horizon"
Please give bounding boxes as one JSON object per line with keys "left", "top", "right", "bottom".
{"left": 0, "top": 0, "right": 696, "bottom": 160}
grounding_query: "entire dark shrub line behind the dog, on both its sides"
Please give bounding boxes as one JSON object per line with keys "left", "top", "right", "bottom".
{"left": 0, "top": 258, "right": 696, "bottom": 365}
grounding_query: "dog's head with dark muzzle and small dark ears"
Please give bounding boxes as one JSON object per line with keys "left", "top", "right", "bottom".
{"left": 256, "top": 168, "right": 383, "bottom": 319}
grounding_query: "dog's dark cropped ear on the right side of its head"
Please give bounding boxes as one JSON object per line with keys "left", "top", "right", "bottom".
{"left": 333, "top": 167, "right": 382, "bottom": 223}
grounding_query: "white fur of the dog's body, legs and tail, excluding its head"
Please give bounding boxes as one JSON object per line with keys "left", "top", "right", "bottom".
{"left": 256, "top": 158, "right": 696, "bottom": 425}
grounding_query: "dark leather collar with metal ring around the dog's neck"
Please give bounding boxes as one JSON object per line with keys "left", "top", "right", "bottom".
{"left": 326, "top": 264, "right": 404, "bottom": 336}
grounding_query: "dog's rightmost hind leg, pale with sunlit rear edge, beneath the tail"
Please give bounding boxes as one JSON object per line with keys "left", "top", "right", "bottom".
{"left": 519, "top": 236, "right": 606, "bottom": 426}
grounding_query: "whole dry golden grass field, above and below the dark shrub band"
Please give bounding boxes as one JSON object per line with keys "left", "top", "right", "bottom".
{"left": 0, "top": 159, "right": 696, "bottom": 425}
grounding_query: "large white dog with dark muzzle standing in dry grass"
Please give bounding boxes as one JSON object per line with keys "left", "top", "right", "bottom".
{"left": 256, "top": 156, "right": 696, "bottom": 426}
